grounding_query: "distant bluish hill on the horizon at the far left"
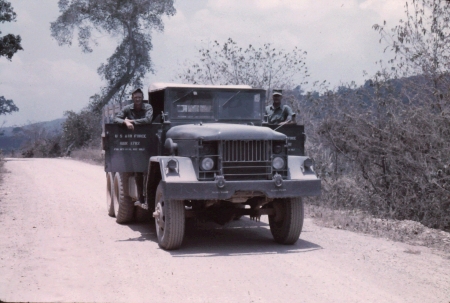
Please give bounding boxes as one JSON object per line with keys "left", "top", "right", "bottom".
{"left": 0, "top": 118, "right": 66, "bottom": 153}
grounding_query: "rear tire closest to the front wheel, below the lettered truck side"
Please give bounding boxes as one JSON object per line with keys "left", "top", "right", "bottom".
{"left": 113, "top": 173, "right": 134, "bottom": 224}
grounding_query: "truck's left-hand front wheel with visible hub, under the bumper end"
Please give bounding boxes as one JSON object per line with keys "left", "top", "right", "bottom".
{"left": 153, "top": 182, "right": 185, "bottom": 250}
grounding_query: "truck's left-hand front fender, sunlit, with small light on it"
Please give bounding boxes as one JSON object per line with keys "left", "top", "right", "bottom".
{"left": 150, "top": 156, "right": 198, "bottom": 183}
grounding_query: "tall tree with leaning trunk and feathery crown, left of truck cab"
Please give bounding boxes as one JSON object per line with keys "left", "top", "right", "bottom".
{"left": 50, "top": 0, "right": 175, "bottom": 111}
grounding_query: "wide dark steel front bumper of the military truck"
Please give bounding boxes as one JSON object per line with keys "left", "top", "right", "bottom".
{"left": 162, "top": 179, "right": 321, "bottom": 200}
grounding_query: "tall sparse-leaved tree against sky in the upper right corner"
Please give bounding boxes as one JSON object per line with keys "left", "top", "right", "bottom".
{"left": 373, "top": 0, "right": 450, "bottom": 111}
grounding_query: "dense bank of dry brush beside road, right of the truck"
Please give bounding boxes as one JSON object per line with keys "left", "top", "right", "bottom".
{"left": 312, "top": 74, "right": 450, "bottom": 229}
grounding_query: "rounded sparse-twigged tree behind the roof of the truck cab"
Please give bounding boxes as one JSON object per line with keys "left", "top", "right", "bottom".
{"left": 176, "top": 38, "right": 309, "bottom": 96}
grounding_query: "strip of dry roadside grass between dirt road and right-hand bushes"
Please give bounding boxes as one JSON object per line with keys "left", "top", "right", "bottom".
{"left": 305, "top": 203, "right": 450, "bottom": 254}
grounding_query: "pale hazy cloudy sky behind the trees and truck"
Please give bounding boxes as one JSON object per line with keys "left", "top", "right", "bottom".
{"left": 0, "top": 0, "right": 405, "bottom": 126}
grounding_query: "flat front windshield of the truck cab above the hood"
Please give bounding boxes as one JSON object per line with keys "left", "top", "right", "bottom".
{"left": 168, "top": 88, "right": 264, "bottom": 121}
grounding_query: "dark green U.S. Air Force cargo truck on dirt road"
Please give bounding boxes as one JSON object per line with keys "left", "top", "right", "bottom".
{"left": 103, "top": 83, "right": 321, "bottom": 250}
